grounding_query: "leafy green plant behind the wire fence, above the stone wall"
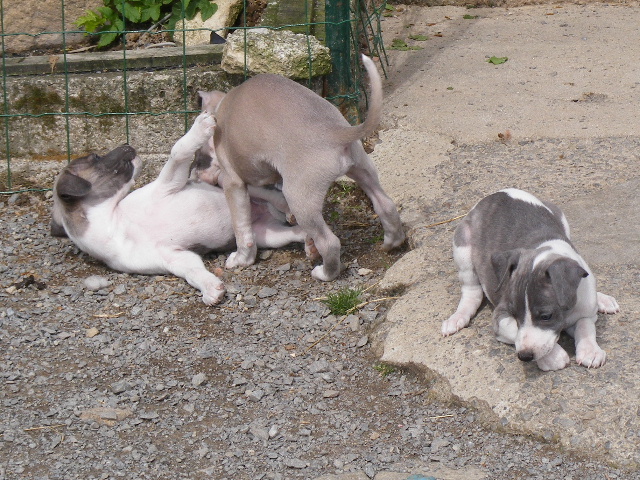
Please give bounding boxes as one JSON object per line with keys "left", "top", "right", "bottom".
{"left": 75, "top": 0, "right": 218, "bottom": 47}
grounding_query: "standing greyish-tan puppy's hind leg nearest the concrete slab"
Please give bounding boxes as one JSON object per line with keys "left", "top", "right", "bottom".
{"left": 347, "top": 145, "right": 406, "bottom": 251}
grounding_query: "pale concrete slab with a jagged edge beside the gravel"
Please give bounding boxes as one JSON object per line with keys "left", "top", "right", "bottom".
{"left": 372, "top": 4, "right": 640, "bottom": 469}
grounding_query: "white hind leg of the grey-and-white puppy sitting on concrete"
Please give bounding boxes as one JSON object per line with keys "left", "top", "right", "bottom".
{"left": 442, "top": 223, "right": 484, "bottom": 337}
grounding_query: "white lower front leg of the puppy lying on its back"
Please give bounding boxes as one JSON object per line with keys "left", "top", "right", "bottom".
{"left": 161, "top": 248, "right": 226, "bottom": 305}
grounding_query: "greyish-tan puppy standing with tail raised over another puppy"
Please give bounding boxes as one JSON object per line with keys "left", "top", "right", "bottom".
{"left": 201, "top": 56, "right": 405, "bottom": 281}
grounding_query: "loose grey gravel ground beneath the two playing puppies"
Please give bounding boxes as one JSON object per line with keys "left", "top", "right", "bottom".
{"left": 0, "top": 172, "right": 630, "bottom": 480}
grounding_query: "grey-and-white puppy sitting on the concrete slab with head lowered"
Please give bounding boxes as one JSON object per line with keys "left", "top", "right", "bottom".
{"left": 442, "top": 188, "right": 620, "bottom": 370}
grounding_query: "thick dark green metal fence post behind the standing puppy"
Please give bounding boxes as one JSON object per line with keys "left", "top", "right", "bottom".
{"left": 325, "top": 0, "right": 358, "bottom": 123}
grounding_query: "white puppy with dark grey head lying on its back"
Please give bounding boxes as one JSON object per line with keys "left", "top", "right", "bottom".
{"left": 51, "top": 113, "right": 306, "bottom": 305}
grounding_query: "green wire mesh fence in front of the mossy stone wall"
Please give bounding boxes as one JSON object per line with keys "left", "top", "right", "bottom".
{"left": 0, "top": 0, "right": 386, "bottom": 194}
